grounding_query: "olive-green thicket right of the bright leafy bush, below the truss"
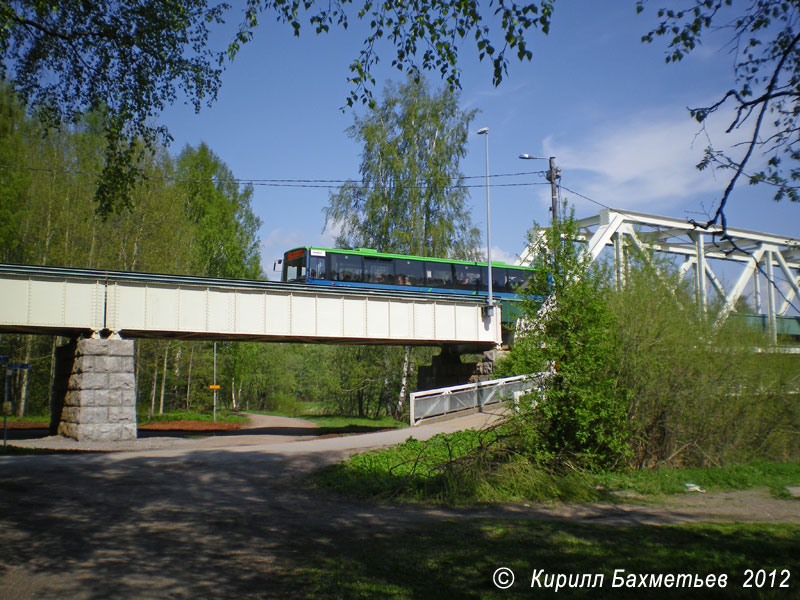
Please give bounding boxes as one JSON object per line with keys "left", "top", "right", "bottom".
{"left": 609, "top": 261, "right": 800, "bottom": 467}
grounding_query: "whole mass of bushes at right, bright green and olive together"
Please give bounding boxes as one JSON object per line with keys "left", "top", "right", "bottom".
{"left": 498, "top": 211, "right": 800, "bottom": 469}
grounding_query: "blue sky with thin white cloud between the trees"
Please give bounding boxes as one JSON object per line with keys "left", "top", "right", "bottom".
{"left": 162, "top": 0, "right": 800, "bottom": 277}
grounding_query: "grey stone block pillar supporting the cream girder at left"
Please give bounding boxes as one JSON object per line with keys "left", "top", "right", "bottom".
{"left": 58, "top": 339, "right": 136, "bottom": 441}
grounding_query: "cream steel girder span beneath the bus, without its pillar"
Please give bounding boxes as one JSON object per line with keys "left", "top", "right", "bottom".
{"left": 0, "top": 265, "right": 502, "bottom": 352}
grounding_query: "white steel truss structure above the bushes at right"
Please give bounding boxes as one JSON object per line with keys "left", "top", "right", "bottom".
{"left": 518, "top": 208, "right": 800, "bottom": 343}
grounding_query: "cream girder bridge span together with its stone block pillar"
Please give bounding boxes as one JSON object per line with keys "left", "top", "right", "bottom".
{"left": 0, "top": 265, "right": 502, "bottom": 440}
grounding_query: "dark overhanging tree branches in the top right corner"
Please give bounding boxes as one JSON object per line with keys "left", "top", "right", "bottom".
{"left": 636, "top": 0, "right": 800, "bottom": 228}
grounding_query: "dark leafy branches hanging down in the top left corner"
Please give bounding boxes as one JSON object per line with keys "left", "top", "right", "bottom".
{"left": 0, "top": 0, "right": 228, "bottom": 216}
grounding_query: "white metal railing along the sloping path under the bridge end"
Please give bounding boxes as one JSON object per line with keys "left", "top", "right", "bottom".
{"left": 410, "top": 373, "right": 543, "bottom": 427}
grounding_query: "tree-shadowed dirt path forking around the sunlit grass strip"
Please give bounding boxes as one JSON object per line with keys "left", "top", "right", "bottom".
{"left": 0, "top": 415, "right": 800, "bottom": 599}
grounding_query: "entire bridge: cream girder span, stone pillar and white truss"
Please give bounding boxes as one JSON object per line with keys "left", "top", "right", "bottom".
{"left": 6, "top": 209, "right": 800, "bottom": 439}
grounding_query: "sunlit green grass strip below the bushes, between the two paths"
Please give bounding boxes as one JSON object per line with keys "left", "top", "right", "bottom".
{"left": 312, "top": 430, "right": 800, "bottom": 504}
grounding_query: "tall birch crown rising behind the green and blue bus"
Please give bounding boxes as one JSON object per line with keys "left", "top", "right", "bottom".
{"left": 325, "top": 78, "right": 479, "bottom": 258}
